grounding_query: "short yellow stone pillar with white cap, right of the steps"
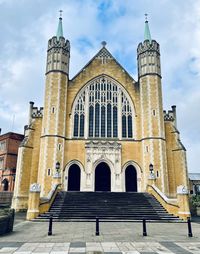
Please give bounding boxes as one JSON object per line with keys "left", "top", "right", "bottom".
{"left": 177, "top": 185, "right": 191, "bottom": 220}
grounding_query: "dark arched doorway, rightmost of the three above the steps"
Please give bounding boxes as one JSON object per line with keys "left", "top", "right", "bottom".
{"left": 125, "top": 165, "right": 137, "bottom": 192}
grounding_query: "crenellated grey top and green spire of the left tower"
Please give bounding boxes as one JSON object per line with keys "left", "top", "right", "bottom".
{"left": 46, "top": 17, "right": 70, "bottom": 75}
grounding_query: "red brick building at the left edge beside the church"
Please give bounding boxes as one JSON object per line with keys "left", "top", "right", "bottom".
{"left": 0, "top": 130, "right": 24, "bottom": 191}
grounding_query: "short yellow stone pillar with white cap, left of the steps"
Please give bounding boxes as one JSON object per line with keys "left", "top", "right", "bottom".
{"left": 26, "top": 183, "right": 41, "bottom": 220}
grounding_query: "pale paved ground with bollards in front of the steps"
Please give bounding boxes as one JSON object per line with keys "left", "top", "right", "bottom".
{"left": 0, "top": 214, "right": 200, "bottom": 254}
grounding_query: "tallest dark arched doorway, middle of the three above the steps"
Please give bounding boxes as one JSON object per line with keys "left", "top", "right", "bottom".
{"left": 95, "top": 162, "right": 111, "bottom": 191}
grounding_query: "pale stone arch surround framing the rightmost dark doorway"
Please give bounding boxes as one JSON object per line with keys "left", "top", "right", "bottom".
{"left": 122, "top": 161, "right": 142, "bottom": 192}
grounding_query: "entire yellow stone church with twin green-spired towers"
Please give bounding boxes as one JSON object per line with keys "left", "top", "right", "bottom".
{"left": 12, "top": 17, "right": 190, "bottom": 218}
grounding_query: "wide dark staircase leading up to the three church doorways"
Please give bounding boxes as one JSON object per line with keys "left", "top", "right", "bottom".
{"left": 36, "top": 191, "right": 178, "bottom": 221}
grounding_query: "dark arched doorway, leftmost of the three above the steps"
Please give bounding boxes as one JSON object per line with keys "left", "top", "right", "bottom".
{"left": 68, "top": 164, "right": 81, "bottom": 191}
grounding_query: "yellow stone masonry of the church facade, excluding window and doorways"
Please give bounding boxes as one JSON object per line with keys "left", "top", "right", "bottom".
{"left": 12, "top": 34, "right": 189, "bottom": 219}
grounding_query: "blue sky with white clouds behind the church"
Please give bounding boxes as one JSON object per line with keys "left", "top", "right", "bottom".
{"left": 0, "top": 0, "right": 200, "bottom": 173}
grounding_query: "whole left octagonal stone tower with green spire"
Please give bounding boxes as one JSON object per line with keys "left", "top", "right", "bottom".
{"left": 38, "top": 14, "right": 70, "bottom": 196}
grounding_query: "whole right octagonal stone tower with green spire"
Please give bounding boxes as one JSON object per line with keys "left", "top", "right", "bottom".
{"left": 137, "top": 15, "right": 168, "bottom": 194}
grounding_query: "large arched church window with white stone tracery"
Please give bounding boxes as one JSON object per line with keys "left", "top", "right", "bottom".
{"left": 73, "top": 76, "right": 133, "bottom": 138}
